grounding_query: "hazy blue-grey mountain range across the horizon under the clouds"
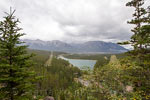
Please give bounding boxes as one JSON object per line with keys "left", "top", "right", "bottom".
{"left": 23, "top": 39, "right": 127, "bottom": 53}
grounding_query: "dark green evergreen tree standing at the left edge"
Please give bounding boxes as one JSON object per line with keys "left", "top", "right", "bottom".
{"left": 0, "top": 11, "right": 34, "bottom": 100}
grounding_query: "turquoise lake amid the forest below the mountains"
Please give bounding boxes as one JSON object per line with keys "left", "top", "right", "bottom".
{"left": 58, "top": 56, "right": 96, "bottom": 69}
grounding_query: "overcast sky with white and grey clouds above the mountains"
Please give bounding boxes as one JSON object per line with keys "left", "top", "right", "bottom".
{"left": 0, "top": 0, "right": 150, "bottom": 42}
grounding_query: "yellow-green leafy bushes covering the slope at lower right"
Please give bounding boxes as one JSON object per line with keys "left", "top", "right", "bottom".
{"left": 89, "top": 56, "right": 150, "bottom": 100}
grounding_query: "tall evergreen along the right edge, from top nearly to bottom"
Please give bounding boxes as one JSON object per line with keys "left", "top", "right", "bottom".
{"left": 119, "top": 0, "right": 150, "bottom": 96}
